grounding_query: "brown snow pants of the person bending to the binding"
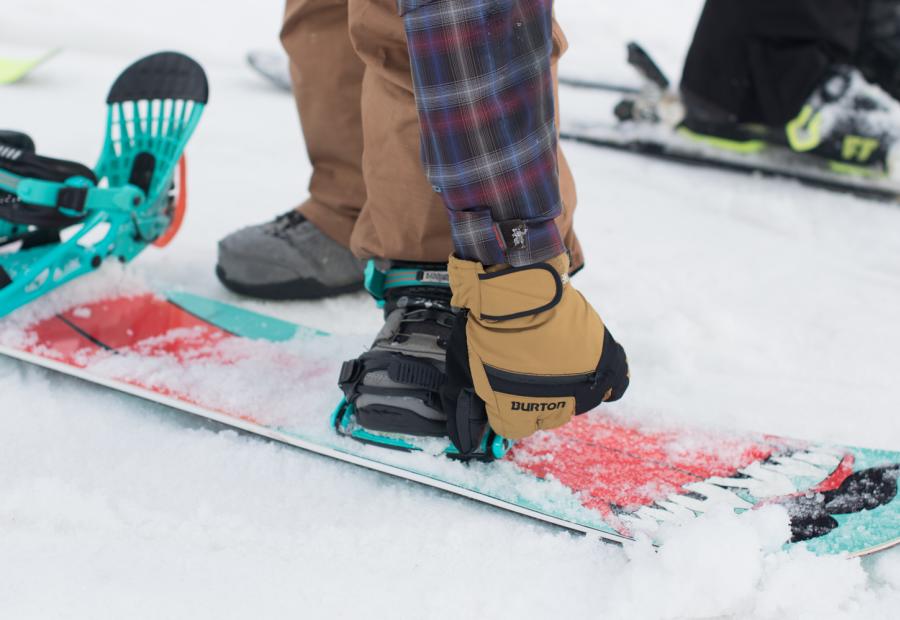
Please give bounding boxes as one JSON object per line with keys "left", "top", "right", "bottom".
{"left": 281, "top": 0, "right": 583, "bottom": 268}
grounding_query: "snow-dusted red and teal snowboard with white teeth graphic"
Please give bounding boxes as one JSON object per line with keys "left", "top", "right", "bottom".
{"left": 0, "top": 274, "right": 900, "bottom": 556}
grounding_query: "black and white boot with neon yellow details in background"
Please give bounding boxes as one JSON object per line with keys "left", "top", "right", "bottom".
{"left": 678, "top": 65, "right": 900, "bottom": 176}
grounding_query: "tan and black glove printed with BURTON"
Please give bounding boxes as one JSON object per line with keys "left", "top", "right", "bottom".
{"left": 441, "top": 254, "right": 629, "bottom": 454}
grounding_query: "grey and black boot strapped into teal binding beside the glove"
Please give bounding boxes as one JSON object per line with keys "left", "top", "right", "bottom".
{"left": 332, "top": 261, "right": 510, "bottom": 461}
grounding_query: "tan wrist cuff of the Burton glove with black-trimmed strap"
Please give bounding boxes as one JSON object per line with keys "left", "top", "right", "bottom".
{"left": 448, "top": 254, "right": 569, "bottom": 322}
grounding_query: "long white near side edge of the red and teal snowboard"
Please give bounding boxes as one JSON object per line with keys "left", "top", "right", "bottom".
{"left": 0, "top": 345, "right": 632, "bottom": 545}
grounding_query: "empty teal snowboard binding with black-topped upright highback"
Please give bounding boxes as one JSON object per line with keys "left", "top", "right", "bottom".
{"left": 0, "top": 52, "right": 209, "bottom": 316}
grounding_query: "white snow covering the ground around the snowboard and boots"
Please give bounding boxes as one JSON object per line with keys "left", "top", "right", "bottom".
{"left": 0, "top": 0, "right": 900, "bottom": 619}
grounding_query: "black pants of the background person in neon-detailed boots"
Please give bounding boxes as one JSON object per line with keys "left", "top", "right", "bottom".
{"left": 681, "top": 0, "right": 866, "bottom": 125}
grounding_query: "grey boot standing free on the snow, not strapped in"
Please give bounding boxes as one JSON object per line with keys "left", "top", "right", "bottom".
{"left": 216, "top": 211, "right": 363, "bottom": 299}
